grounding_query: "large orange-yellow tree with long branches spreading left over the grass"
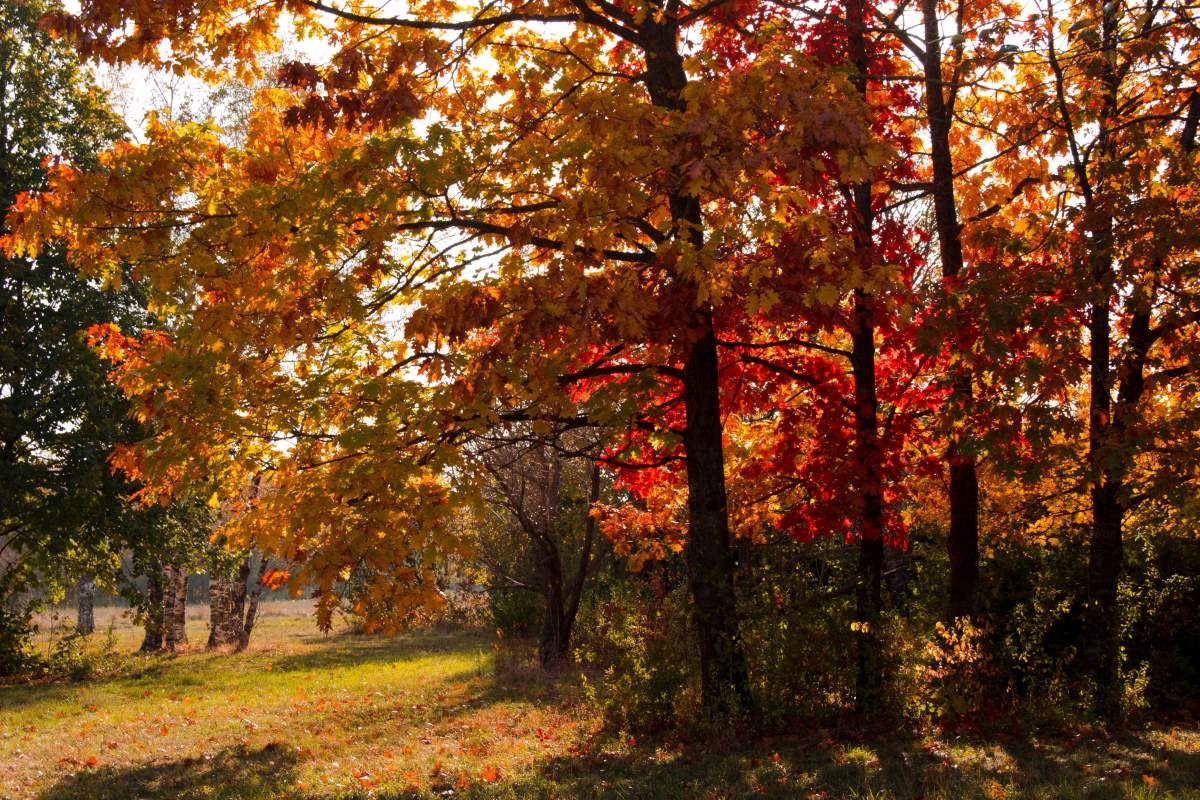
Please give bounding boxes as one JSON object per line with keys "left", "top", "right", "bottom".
{"left": 11, "top": 2, "right": 886, "bottom": 709}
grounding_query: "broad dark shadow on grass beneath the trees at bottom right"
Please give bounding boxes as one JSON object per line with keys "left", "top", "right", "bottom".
{"left": 444, "top": 734, "right": 1200, "bottom": 800}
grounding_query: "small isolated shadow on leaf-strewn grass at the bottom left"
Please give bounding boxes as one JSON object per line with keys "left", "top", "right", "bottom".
{"left": 38, "top": 745, "right": 296, "bottom": 800}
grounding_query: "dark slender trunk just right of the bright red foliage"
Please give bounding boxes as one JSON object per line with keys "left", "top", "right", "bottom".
{"left": 922, "top": 0, "right": 979, "bottom": 621}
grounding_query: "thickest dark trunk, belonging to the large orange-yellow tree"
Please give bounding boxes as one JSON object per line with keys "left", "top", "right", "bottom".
{"left": 638, "top": 14, "right": 751, "bottom": 714}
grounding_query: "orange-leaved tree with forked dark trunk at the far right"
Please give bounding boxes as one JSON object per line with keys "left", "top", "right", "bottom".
{"left": 936, "top": 2, "right": 1200, "bottom": 715}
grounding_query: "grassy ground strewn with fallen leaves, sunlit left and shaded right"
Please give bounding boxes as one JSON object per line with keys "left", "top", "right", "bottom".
{"left": 0, "top": 602, "right": 1200, "bottom": 800}
